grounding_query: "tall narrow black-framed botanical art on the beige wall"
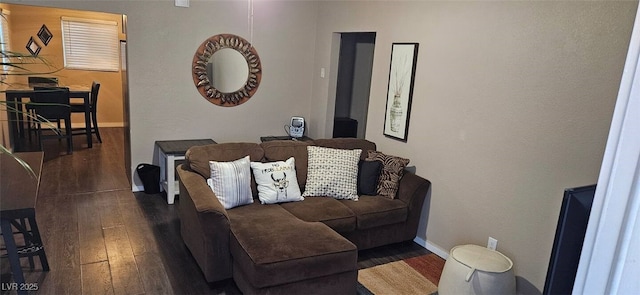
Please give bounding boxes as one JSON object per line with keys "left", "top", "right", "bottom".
{"left": 384, "top": 43, "right": 418, "bottom": 142}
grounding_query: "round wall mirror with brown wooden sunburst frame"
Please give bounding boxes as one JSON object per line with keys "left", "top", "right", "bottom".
{"left": 192, "top": 34, "right": 262, "bottom": 107}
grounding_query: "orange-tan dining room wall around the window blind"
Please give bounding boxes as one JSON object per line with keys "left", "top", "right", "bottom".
{"left": 2, "top": 4, "right": 126, "bottom": 127}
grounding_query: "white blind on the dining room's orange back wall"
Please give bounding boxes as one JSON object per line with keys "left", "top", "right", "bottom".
{"left": 62, "top": 17, "right": 120, "bottom": 72}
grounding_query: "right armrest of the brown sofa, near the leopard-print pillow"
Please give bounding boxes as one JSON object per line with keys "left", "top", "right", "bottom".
{"left": 397, "top": 170, "right": 431, "bottom": 239}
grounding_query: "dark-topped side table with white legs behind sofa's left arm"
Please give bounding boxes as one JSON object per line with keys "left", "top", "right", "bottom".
{"left": 156, "top": 139, "right": 216, "bottom": 204}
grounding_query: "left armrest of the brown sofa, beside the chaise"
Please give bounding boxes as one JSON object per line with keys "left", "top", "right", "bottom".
{"left": 176, "top": 164, "right": 232, "bottom": 282}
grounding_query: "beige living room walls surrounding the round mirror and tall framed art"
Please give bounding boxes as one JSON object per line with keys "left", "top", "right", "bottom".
{"left": 5, "top": 0, "right": 637, "bottom": 290}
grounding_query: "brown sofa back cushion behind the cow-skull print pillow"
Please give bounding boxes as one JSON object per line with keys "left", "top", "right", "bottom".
{"left": 260, "top": 140, "right": 311, "bottom": 191}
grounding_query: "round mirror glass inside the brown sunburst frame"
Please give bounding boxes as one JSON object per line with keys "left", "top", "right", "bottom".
{"left": 207, "top": 48, "right": 249, "bottom": 93}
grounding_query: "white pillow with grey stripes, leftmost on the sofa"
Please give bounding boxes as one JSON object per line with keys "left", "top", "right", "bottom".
{"left": 207, "top": 156, "right": 253, "bottom": 209}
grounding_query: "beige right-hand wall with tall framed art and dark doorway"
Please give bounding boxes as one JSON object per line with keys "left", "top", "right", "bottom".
{"left": 312, "top": 1, "right": 637, "bottom": 290}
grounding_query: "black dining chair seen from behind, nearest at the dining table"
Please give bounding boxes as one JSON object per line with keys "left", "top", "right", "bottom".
{"left": 31, "top": 87, "right": 73, "bottom": 154}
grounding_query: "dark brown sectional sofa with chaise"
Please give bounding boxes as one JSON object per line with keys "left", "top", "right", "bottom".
{"left": 177, "top": 138, "right": 431, "bottom": 294}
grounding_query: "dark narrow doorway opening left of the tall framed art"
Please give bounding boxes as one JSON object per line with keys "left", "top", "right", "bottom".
{"left": 333, "top": 32, "right": 376, "bottom": 138}
